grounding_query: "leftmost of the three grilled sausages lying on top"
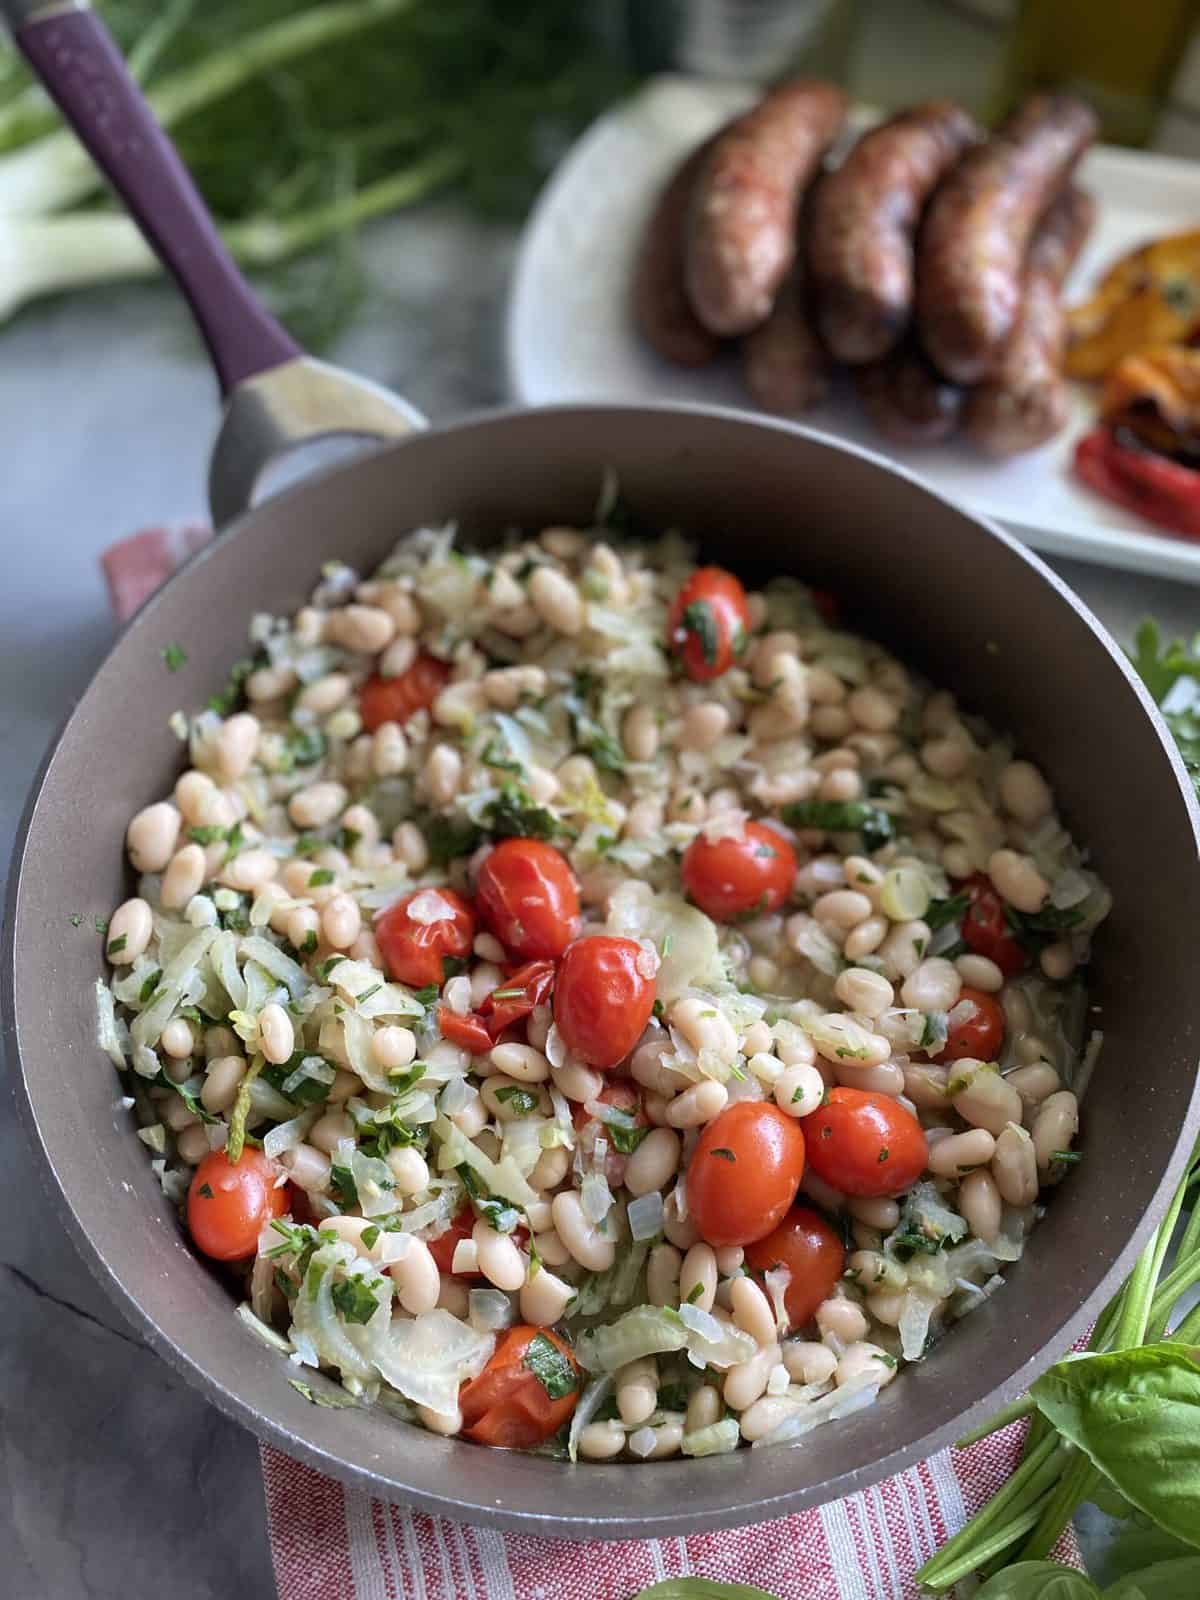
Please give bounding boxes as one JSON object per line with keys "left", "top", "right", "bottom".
{"left": 685, "top": 80, "right": 846, "bottom": 334}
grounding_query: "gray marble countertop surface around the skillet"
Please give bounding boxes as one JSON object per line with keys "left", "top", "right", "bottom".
{"left": 0, "top": 206, "right": 1200, "bottom": 1600}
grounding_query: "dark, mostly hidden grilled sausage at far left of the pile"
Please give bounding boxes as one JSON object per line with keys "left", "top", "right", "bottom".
{"left": 634, "top": 139, "right": 720, "bottom": 366}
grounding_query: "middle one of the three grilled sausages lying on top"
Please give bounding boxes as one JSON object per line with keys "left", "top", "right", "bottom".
{"left": 808, "top": 99, "right": 979, "bottom": 365}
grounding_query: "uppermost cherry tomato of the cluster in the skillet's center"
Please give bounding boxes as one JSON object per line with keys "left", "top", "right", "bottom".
{"left": 475, "top": 838, "right": 579, "bottom": 962}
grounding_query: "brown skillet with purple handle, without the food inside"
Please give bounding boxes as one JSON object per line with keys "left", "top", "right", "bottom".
{"left": 3, "top": 0, "right": 1200, "bottom": 1539}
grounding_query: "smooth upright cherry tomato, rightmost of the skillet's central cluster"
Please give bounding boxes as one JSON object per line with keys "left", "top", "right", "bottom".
{"left": 554, "top": 934, "right": 654, "bottom": 1072}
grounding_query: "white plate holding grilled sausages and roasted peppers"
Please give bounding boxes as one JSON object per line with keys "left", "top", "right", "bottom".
{"left": 507, "top": 78, "right": 1200, "bottom": 582}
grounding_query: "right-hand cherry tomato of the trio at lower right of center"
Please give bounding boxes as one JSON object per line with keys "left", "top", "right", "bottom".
{"left": 802, "top": 1088, "right": 926, "bottom": 1195}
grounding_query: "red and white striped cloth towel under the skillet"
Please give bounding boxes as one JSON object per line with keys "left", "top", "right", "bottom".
{"left": 102, "top": 523, "right": 1080, "bottom": 1600}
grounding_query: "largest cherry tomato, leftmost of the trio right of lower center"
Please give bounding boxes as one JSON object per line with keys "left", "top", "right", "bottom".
{"left": 688, "top": 1101, "right": 805, "bottom": 1250}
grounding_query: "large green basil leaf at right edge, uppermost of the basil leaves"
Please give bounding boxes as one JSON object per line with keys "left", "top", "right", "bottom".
{"left": 1030, "top": 1344, "right": 1200, "bottom": 1546}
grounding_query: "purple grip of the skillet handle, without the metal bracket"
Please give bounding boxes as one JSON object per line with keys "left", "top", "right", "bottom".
{"left": 10, "top": 0, "right": 302, "bottom": 395}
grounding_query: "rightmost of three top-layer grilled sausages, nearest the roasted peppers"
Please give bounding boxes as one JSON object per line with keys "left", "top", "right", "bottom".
{"left": 917, "top": 94, "right": 1098, "bottom": 384}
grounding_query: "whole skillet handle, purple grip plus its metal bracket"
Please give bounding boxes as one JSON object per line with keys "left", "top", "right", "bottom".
{"left": 0, "top": 0, "right": 424, "bottom": 528}
